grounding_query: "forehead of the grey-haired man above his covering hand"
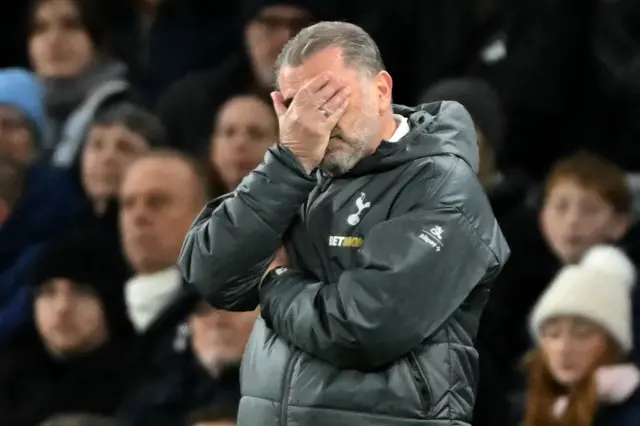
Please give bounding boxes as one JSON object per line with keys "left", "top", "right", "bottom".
{"left": 278, "top": 47, "right": 359, "bottom": 99}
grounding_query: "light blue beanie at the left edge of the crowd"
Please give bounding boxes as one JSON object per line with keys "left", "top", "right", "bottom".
{"left": 0, "top": 68, "right": 47, "bottom": 140}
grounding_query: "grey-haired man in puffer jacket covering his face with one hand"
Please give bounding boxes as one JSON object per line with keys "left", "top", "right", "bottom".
{"left": 179, "top": 22, "right": 509, "bottom": 426}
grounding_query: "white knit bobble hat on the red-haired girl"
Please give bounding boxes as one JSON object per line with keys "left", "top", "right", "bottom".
{"left": 530, "top": 245, "right": 636, "bottom": 352}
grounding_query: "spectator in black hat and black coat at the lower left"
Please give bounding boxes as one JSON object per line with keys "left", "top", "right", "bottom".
{"left": 0, "top": 234, "right": 137, "bottom": 425}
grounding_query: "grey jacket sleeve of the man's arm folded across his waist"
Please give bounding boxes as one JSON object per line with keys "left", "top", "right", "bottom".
{"left": 260, "top": 163, "right": 501, "bottom": 370}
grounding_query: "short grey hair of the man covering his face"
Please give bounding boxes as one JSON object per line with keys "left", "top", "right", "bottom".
{"left": 275, "top": 21, "right": 385, "bottom": 88}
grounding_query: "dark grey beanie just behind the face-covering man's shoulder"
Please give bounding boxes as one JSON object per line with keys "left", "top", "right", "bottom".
{"left": 420, "top": 78, "right": 506, "bottom": 151}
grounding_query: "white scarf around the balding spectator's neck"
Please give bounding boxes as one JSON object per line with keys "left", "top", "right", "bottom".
{"left": 124, "top": 266, "right": 182, "bottom": 333}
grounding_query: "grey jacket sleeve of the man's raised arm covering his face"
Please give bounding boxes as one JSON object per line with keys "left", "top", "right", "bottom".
{"left": 178, "top": 146, "right": 315, "bottom": 311}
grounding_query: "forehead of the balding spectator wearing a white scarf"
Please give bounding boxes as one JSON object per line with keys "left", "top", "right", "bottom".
{"left": 122, "top": 157, "right": 197, "bottom": 195}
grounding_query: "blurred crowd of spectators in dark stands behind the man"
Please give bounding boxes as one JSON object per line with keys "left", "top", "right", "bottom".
{"left": 0, "top": 0, "right": 640, "bottom": 426}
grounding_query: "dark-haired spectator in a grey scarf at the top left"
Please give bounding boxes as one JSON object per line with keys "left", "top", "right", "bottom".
{"left": 28, "top": 0, "right": 140, "bottom": 167}
